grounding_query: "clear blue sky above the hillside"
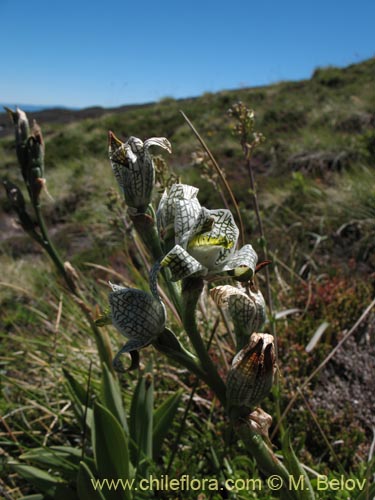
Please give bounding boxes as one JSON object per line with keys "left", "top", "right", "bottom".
{"left": 0, "top": 0, "right": 375, "bottom": 107}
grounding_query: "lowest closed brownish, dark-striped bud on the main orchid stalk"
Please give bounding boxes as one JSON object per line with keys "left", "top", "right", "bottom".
{"left": 227, "top": 333, "right": 275, "bottom": 418}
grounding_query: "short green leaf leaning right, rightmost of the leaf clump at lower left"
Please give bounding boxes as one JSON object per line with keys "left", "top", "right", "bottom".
{"left": 152, "top": 390, "right": 182, "bottom": 459}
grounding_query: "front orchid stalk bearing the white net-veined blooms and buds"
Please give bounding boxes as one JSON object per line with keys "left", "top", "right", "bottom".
{"left": 97, "top": 132, "right": 313, "bottom": 498}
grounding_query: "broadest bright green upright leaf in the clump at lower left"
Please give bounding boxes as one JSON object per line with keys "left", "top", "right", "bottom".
{"left": 92, "top": 402, "right": 131, "bottom": 500}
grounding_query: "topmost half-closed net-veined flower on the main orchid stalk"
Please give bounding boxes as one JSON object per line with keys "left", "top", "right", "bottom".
{"left": 108, "top": 132, "right": 172, "bottom": 215}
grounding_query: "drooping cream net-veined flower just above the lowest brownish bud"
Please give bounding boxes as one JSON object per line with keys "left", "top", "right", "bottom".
{"left": 210, "top": 285, "right": 266, "bottom": 351}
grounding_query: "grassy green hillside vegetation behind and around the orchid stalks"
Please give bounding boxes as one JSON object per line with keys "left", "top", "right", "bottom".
{"left": 0, "top": 59, "right": 375, "bottom": 500}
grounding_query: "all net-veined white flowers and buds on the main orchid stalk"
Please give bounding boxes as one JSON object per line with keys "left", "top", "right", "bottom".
{"left": 103, "top": 132, "right": 275, "bottom": 418}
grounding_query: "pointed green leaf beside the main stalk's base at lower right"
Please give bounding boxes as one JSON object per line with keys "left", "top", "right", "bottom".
{"left": 283, "top": 432, "right": 315, "bottom": 500}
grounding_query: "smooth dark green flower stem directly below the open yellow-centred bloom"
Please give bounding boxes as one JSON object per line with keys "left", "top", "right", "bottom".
{"left": 182, "top": 278, "right": 226, "bottom": 407}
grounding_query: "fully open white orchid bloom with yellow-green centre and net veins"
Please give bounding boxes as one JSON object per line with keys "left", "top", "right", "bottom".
{"left": 158, "top": 189, "right": 258, "bottom": 281}
